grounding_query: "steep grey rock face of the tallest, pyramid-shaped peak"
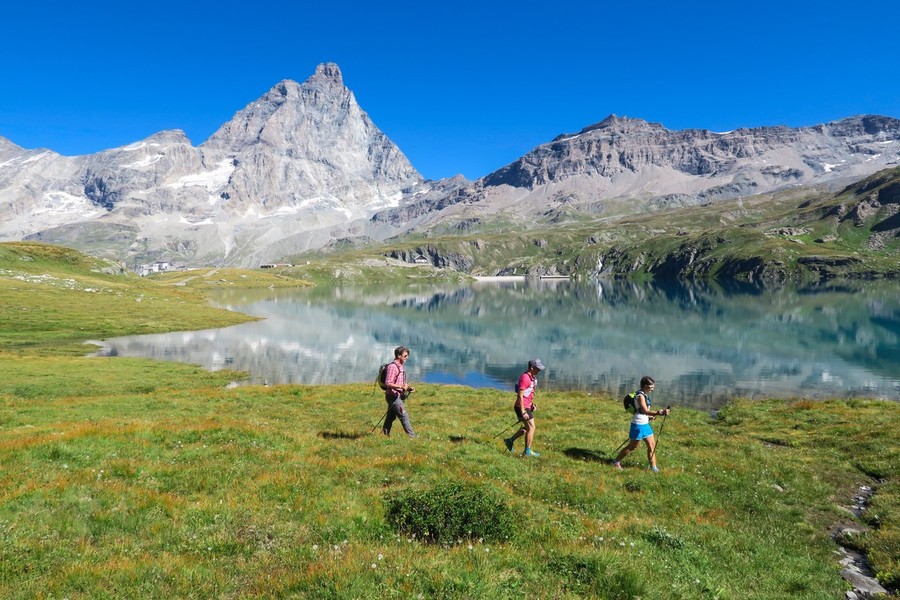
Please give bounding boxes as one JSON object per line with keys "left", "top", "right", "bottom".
{"left": 200, "top": 64, "right": 422, "bottom": 218}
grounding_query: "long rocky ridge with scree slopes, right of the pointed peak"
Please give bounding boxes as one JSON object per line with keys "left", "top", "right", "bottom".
{"left": 377, "top": 115, "right": 900, "bottom": 233}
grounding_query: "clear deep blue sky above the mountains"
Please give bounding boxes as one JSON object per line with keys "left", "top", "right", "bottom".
{"left": 0, "top": 0, "right": 900, "bottom": 179}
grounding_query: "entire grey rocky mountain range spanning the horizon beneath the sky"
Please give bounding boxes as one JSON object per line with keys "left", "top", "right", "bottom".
{"left": 0, "top": 63, "right": 900, "bottom": 266}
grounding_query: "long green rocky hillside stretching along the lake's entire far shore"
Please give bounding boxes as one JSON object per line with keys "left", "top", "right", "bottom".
{"left": 294, "top": 169, "right": 900, "bottom": 283}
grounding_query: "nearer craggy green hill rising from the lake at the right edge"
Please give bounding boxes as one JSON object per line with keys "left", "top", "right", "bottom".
{"left": 596, "top": 169, "right": 900, "bottom": 282}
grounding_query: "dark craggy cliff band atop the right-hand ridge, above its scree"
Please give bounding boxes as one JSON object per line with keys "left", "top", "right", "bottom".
{"left": 483, "top": 116, "right": 900, "bottom": 186}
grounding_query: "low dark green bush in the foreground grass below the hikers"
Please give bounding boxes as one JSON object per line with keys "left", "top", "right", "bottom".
{"left": 385, "top": 481, "right": 515, "bottom": 544}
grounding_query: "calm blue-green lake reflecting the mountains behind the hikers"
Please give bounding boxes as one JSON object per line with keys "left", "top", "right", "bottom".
{"left": 95, "top": 281, "right": 900, "bottom": 410}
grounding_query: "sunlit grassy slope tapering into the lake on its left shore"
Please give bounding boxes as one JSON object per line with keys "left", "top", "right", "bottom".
{"left": 0, "top": 242, "right": 303, "bottom": 354}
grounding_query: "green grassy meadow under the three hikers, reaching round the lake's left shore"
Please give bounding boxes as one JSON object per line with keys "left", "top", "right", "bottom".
{"left": 0, "top": 245, "right": 900, "bottom": 600}
